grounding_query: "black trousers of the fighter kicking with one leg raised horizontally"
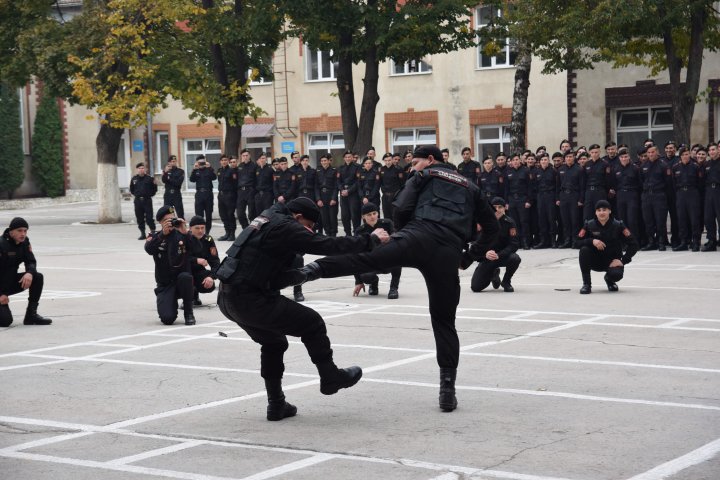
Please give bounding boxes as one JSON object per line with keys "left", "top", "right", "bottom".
{"left": 317, "top": 231, "right": 461, "bottom": 368}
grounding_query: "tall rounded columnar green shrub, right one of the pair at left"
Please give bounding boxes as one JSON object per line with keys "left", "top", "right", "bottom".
{"left": 32, "top": 95, "right": 65, "bottom": 197}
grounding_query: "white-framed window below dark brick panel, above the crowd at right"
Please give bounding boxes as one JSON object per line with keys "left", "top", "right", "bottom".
{"left": 615, "top": 106, "right": 673, "bottom": 149}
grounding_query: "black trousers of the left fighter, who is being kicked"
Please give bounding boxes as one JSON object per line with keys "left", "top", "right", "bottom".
{"left": 218, "top": 284, "right": 332, "bottom": 379}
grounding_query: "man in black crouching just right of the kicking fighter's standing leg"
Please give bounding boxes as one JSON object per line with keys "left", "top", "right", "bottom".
{"left": 470, "top": 196, "right": 520, "bottom": 292}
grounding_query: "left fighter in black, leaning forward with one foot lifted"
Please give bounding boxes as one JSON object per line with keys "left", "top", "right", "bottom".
{"left": 218, "top": 197, "right": 389, "bottom": 421}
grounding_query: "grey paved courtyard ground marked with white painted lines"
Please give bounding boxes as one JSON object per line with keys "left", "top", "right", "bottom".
{"left": 0, "top": 202, "right": 720, "bottom": 480}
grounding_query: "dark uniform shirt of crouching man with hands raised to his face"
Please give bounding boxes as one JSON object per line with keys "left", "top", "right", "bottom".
{"left": 145, "top": 229, "right": 193, "bottom": 287}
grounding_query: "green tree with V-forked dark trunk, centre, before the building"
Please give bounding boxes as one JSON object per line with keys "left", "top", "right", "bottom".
{"left": 281, "top": 0, "right": 477, "bottom": 153}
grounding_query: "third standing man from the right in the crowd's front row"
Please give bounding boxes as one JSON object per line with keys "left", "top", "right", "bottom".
{"left": 640, "top": 145, "right": 672, "bottom": 252}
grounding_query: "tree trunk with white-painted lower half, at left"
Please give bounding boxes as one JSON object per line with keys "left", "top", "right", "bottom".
{"left": 95, "top": 125, "right": 123, "bottom": 223}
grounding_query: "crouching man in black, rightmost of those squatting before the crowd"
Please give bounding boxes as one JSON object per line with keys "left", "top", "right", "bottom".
{"left": 578, "top": 200, "right": 639, "bottom": 294}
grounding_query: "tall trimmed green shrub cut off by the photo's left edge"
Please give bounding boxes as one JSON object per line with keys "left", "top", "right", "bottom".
{"left": 0, "top": 84, "right": 25, "bottom": 197}
